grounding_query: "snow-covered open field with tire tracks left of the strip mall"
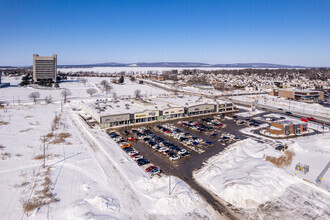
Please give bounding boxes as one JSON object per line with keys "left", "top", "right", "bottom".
{"left": 0, "top": 83, "right": 219, "bottom": 219}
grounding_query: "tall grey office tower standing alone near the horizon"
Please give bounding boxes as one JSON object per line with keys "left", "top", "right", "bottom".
{"left": 33, "top": 54, "right": 57, "bottom": 83}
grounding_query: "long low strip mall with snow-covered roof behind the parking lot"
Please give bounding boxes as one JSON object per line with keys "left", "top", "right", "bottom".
{"left": 81, "top": 97, "right": 237, "bottom": 128}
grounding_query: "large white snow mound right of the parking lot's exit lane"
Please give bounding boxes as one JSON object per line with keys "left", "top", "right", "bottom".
{"left": 194, "top": 139, "right": 295, "bottom": 209}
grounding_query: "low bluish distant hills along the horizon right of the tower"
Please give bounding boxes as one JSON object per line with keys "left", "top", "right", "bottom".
{"left": 58, "top": 62, "right": 308, "bottom": 68}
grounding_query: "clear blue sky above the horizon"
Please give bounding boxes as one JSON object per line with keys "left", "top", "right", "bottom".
{"left": 0, "top": 0, "right": 330, "bottom": 66}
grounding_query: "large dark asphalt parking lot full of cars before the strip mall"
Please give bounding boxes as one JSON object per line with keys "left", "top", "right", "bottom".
{"left": 109, "top": 115, "right": 246, "bottom": 180}
